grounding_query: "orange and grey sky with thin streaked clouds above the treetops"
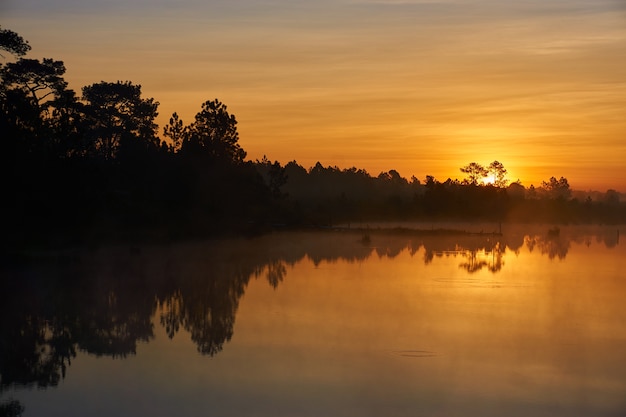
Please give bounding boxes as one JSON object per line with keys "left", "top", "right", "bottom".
{"left": 0, "top": 0, "right": 626, "bottom": 192}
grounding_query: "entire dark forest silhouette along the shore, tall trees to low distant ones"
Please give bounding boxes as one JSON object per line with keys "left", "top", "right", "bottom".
{"left": 0, "top": 29, "right": 626, "bottom": 249}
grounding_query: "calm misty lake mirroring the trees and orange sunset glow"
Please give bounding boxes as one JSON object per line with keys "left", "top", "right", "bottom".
{"left": 0, "top": 226, "right": 626, "bottom": 417}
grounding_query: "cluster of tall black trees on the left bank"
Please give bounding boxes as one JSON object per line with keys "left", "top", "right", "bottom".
{"left": 0, "top": 32, "right": 279, "bottom": 248}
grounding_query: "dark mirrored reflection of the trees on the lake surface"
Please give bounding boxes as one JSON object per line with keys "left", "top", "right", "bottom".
{"left": 0, "top": 226, "right": 619, "bottom": 415}
